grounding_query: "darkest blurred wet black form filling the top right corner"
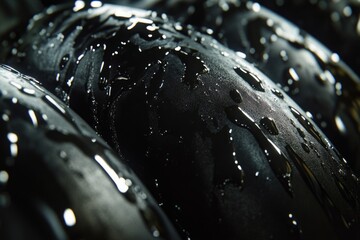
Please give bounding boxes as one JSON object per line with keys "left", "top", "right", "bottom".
{"left": 258, "top": 0, "right": 360, "bottom": 77}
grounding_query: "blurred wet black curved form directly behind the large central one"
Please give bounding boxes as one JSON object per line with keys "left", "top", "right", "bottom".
{"left": 148, "top": 1, "right": 360, "bottom": 175}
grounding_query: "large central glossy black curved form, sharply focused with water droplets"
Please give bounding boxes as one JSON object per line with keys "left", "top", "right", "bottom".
{"left": 2, "top": 5, "right": 360, "bottom": 239}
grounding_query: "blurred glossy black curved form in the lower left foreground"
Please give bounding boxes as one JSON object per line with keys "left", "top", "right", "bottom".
{"left": 0, "top": 65, "right": 180, "bottom": 240}
